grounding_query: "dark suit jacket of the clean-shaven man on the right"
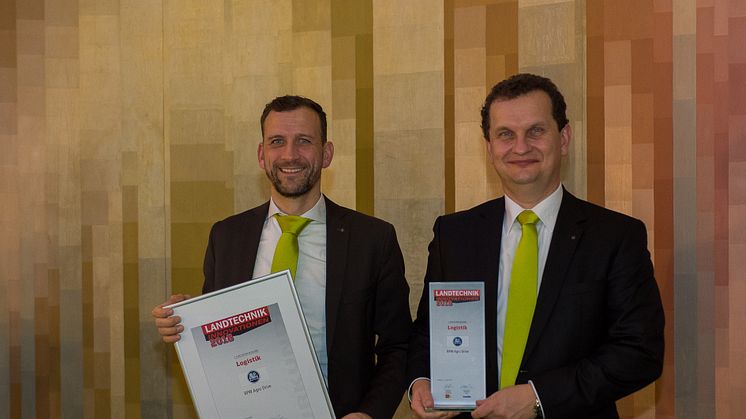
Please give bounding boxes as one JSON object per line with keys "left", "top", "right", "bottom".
{"left": 408, "top": 191, "right": 664, "bottom": 419}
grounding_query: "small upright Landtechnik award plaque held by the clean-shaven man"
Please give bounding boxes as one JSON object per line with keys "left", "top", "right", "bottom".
{"left": 429, "top": 282, "right": 486, "bottom": 411}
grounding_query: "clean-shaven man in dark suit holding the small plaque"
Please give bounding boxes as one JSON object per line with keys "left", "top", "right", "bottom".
{"left": 408, "top": 74, "right": 664, "bottom": 419}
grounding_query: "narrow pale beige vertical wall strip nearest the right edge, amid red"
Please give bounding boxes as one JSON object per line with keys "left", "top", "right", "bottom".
{"left": 663, "top": 1, "right": 700, "bottom": 417}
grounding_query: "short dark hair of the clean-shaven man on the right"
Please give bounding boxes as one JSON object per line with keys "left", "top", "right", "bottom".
{"left": 482, "top": 73, "right": 569, "bottom": 141}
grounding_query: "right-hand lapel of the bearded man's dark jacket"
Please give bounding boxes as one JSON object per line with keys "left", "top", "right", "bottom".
{"left": 324, "top": 196, "right": 350, "bottom": 353}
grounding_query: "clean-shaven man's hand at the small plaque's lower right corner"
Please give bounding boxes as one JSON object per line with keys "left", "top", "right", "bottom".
{"left": 471, "top": 384, "right": 536, "bottom": 419}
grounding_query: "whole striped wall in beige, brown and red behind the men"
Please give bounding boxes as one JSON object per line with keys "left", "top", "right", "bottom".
{"left": 0, "top": 0, "right": 746, "bottom": 418}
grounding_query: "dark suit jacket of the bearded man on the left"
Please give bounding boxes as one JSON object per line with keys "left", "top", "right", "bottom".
{"left": 202, "top": 198, "right": 412, "bottom": 418}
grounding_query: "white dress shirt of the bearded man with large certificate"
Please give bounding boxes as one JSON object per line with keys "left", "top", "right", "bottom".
{"left": 252, "top": 195, "right": 329, "bottom": 380}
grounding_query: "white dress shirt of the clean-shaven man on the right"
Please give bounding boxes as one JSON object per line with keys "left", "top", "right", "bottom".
{"left": 497, "top": 185, "right": 562, "bottom": 388}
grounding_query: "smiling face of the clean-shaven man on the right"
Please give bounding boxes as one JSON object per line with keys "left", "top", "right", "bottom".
{"left": 487, "top": 90, "right": 572, "bottom": 208}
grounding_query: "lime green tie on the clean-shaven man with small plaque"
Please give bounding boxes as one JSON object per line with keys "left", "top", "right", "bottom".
{"left": 500, "top": 210, "right": 539, "bottom": 388}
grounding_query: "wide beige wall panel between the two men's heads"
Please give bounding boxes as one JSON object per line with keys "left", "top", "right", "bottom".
{"left": 373, "top": 1, "right": 445, "bottom": 334}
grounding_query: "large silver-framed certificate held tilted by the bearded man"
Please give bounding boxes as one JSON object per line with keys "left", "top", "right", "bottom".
{"left": 170, "top": 271, "right": 334, "bottom": 419}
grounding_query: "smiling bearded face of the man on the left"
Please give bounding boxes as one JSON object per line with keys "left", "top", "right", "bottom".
{"left": 257, "top": 107, "right": 334, "bottom": 209}
